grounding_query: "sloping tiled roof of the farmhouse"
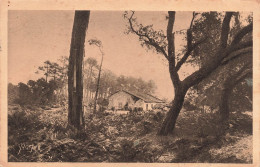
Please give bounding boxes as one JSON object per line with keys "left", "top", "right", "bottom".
{"left": 111, "top": 90, "right": 164, "bottom": 103}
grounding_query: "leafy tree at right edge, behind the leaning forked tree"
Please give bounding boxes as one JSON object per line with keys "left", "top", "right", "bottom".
{"left": 184, "top": 12, "right": 252, "bottom": 124}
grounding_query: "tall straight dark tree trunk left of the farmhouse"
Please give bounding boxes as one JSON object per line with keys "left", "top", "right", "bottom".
{"left": 68, "top": 11, "right": 90, "bottom": 129}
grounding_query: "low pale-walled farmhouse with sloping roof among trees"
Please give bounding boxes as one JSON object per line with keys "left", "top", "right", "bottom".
{"left": 108, "top": 90, "right": 165, "bottom": 111}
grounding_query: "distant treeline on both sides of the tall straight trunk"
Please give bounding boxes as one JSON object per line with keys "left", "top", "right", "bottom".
{"left": 8, "top": 57, "right": 156, "bottom": 107}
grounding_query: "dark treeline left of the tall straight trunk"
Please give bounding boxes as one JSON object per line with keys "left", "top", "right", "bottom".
{"left": 8, "top": 57, "right": 68, "bottom": 106}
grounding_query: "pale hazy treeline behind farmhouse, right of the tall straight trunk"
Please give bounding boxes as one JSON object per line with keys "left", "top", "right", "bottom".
{"left": 84, "top": 57, "right": 156, "bottom": 104}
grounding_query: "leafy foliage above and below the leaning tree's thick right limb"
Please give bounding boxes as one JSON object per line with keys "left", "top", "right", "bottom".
{"left": 184, "top": 12, "right": 252, "bottom": 117}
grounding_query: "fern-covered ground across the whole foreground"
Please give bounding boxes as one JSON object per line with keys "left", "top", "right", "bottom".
{"left": 8, "top": 106, "right": 252, "bottom": 163}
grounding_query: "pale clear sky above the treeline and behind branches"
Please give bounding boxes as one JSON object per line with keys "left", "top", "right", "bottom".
{"left": 8, "top": 10, "right": 192, "bottom": 99}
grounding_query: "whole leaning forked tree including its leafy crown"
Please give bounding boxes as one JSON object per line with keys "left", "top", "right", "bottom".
{"left": 123, "top": 11, "right": 253, "bottom": 136}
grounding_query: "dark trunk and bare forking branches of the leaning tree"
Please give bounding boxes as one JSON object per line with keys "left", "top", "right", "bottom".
{"left": 124, "top": 11, "right": 253, "bottom": 135}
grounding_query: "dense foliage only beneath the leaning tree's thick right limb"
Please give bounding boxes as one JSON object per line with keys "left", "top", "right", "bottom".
{"left": 191, "top": 51, "right": 252, "bottom": 116}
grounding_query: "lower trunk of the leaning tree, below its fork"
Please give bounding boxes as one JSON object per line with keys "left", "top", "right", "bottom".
{"left": 157, "top": 88, "right": 187, "bottom": 136}
